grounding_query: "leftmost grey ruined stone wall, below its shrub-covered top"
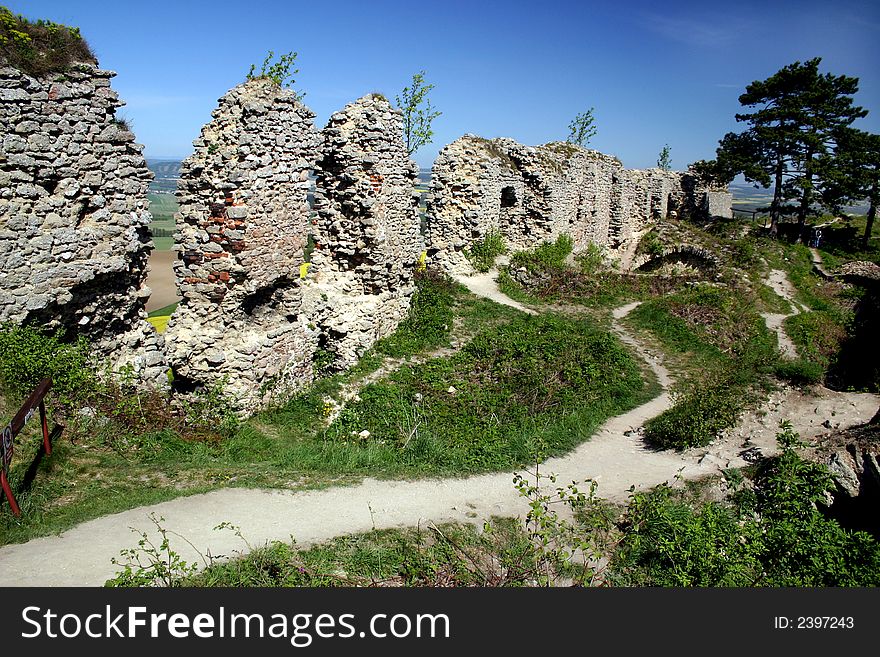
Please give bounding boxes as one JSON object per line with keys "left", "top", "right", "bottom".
{"left": 0, "top": 64, "right": 166, "bottom": 384}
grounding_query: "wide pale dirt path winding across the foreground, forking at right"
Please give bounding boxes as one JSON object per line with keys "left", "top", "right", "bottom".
{"left": 0, "top": 276, "right": 880, "bottom": 586}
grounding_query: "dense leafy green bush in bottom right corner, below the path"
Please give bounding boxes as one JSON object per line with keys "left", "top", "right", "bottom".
{"left": 610, "top": 425, "right": 880, "bottom": 587}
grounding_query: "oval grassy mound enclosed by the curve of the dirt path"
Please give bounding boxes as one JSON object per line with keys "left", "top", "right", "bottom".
{"left": 314, "top": 315, "right": 653, "bottom": 474}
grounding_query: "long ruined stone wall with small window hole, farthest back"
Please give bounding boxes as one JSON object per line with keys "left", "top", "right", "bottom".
{"left": 426, "top": 135, "right": 683, "bottom": 274}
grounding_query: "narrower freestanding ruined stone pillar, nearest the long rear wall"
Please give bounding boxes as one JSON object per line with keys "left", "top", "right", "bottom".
{"left": 306, "top": 94, "right": 424, "bottom": 367}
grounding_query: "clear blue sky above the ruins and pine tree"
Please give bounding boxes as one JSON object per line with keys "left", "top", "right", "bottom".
{"left": 15, "top": 0, "right": 880, "bottom": 169}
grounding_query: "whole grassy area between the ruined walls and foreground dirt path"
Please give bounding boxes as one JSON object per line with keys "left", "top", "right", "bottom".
{"left": 0, "top": 274, "right": 656, "bottom": 543}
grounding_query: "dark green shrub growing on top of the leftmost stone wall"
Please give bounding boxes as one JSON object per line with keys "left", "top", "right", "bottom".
{"left": 0, "top": 7, "right": 95, "bottom": 77}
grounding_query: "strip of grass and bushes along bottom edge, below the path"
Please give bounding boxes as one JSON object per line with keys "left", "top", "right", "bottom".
{"left": 108, "top": 426, "right": 880, "bottom": 588}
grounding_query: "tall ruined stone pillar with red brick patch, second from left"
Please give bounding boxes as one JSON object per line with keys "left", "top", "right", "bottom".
{"left": 166, "top": 79, "right": 320, "bottom": 410}
